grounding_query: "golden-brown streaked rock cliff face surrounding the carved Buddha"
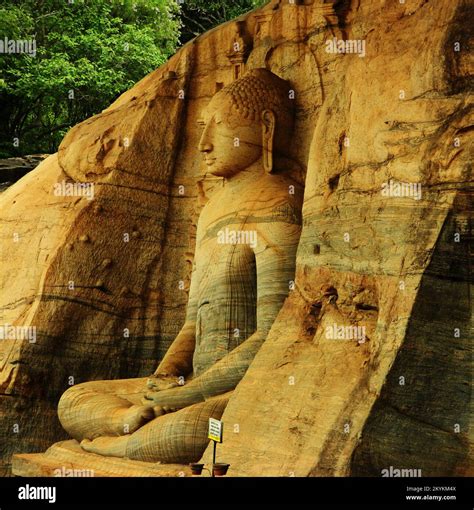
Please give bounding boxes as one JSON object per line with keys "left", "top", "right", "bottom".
{"left": 0, "top": 0, "right": 473, "bottom": 476}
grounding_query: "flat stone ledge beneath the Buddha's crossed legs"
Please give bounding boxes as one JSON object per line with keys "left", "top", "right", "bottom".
{"left": 12, "top": 440, "right": 191, "bottom": 477}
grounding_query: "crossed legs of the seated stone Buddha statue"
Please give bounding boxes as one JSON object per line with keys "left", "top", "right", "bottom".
{"left": 58, "top": 378, "right": 231, "bottom": 463}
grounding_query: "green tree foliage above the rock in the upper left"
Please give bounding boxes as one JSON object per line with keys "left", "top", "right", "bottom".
{"left": 0, "top": 0, "right": 265, "bottom": 157}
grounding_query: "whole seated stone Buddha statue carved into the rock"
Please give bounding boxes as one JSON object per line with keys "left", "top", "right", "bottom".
{"left": 58, "top": 69, "right": 303, "bottom": 463}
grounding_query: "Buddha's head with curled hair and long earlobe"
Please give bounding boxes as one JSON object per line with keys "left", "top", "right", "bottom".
{"left": 199, "top": 69, "right": 294, "bottom": 178}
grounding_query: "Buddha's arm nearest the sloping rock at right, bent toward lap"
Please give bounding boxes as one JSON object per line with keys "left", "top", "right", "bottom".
{"left": 148, "top": 223, "right": 300, "bottom": 408}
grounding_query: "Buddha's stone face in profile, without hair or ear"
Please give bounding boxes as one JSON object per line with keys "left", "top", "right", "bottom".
{"left": 199, "top": 93, "right": 262, "bottom": 177}
